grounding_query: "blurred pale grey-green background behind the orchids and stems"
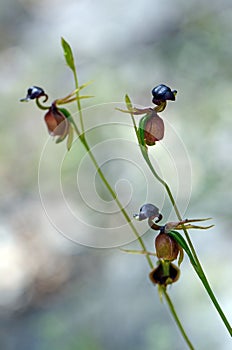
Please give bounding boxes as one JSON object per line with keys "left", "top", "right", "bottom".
{"left": 0, "top": 0, "right": 232, "bottom": 350}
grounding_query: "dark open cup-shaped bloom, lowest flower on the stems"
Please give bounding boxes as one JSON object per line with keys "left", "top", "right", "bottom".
{"left": 149, "top": 261, "right": 180, "bottom": 287}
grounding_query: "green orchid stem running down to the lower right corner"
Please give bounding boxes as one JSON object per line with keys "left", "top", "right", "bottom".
{"left": 131, "top": 113, "right": 232, "bottom": 336}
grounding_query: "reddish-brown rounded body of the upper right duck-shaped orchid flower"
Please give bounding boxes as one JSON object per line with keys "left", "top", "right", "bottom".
{"left": 139, "top": 110, "right": 164, "bottom": 146}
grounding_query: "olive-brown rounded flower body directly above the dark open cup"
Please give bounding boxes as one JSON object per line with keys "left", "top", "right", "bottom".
{"left": 155, "top": 233, "right": 180, "bottom": 261}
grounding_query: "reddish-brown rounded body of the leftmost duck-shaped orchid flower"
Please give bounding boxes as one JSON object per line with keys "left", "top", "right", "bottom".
{"left": 44, "top": 103, "right": 70, "bottom": 140}
